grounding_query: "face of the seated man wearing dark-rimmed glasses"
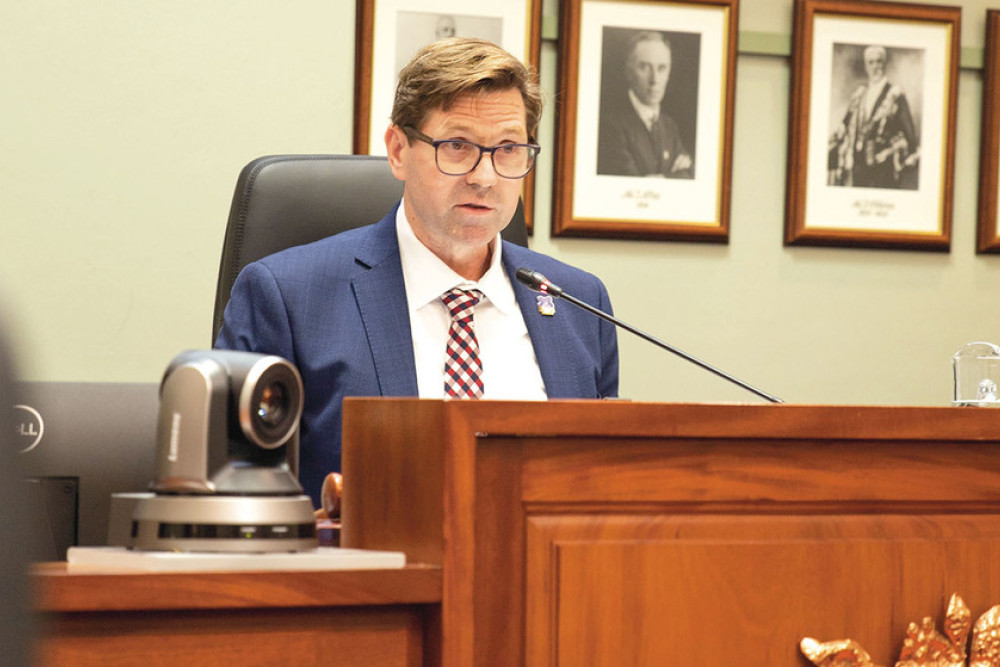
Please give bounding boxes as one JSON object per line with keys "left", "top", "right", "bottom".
{"left": 386, "top": 88, "right": 528, "bottom": 275}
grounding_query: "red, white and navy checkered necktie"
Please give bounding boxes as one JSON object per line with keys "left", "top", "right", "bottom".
{"left": 441, "top": 289, "right": 483, "bottom": 398}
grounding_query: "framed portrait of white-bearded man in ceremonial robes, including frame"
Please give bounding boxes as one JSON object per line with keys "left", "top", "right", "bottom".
{"left": 785, "top": 0, "right": 961, "bottom": 251}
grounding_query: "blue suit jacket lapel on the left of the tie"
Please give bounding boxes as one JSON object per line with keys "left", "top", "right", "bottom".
{"left": 351, "top": 208, "right": 418, "bottom": 396}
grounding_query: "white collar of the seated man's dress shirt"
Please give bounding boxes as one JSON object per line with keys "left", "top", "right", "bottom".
{"left": 396, "top": 204, "right": 517, "bottom": 313}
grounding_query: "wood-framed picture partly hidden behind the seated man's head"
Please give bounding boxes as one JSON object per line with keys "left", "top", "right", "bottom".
{"left": 353, "top": 0, "right": 545, "bottom": 233}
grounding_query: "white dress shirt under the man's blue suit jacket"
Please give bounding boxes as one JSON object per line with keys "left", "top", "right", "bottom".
{"left": 396, "top": 204, "right": 547, "bottom": 401}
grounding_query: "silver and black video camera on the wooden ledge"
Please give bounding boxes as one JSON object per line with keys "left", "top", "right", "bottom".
{"left": 127, "top": 350, "right": 317, "bottom": 552}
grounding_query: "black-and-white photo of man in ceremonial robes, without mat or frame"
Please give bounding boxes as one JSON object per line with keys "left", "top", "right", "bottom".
{"left": 827, "top": 44, "right": 920, "bottom": 190}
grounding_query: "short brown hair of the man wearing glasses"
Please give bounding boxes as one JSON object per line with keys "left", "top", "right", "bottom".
{"left": 391, "top": 37, "right": 542, "bottom": 141}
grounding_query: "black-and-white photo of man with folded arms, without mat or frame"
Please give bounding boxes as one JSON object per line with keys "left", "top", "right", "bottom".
{"left": 597, "top": 28, "right": 697, "bottom": 178}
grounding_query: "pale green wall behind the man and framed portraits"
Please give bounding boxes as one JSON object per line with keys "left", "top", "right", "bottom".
{"left": 0, "top": 0, "right": 1000, "bottom": 405}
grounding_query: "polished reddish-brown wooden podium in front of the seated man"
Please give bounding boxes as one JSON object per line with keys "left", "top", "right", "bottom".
{"left": 342, "top": 399, "right": 1000, "bottom": 667}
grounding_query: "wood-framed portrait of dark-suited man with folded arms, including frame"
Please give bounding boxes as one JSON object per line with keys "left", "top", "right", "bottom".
{"left": 552, "top": 0, "right": 739, "bottom": 243}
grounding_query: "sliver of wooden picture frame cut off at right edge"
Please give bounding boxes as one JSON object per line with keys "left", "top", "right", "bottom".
{"left": 976, "top": 9, "right": 1000, "bottom": 253}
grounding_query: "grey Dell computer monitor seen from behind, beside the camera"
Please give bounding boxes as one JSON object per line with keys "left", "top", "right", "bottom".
{"left": 13, "top": 382, "right": 159, "bottom": 561}
